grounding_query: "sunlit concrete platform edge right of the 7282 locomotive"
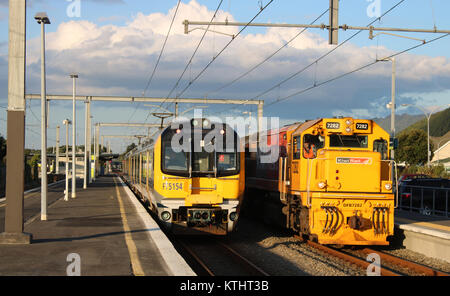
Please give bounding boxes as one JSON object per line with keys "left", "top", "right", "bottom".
{"left": 395, "top": 211, "right": 450, "bottom": 262}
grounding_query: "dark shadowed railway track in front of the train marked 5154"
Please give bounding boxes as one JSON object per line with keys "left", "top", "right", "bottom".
{"left": 177, "top": 238, "right": 269, "bottom": 276}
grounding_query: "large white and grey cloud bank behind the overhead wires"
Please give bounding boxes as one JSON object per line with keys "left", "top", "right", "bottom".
{"left": 23, "top": 0, "right": 450, "bottom": 122}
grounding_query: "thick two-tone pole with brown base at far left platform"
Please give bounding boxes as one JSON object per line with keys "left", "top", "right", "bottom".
{"left": 0, "top": 0, "right": 32, "bottom": 244}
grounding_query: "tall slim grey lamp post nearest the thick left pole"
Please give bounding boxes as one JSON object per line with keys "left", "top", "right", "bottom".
{"left": 34, "top": 12, "right": 50, "bottom": 220}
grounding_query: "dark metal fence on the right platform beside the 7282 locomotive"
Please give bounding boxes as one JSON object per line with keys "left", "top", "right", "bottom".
{"left": 398, "top": 185, "right": 450, "bottom": 218}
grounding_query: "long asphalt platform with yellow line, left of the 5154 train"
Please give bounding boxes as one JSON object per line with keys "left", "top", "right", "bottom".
{"left": 0, "top": 177, "right": 195, "bottom": 276}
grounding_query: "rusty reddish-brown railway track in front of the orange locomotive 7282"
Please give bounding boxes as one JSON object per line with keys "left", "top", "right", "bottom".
{"left": 296, "top": 236, "right": 449, "bottom": 276}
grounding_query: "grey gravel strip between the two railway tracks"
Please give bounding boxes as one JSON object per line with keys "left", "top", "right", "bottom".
{"left": 229, "top": 217, "right": 365, "bottom": 276}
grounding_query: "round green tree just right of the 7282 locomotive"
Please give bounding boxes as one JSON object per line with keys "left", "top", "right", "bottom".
{"left": 395, "top": 129, "right": 433, "bottom": 165}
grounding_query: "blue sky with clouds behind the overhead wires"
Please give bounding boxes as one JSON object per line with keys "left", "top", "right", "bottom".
{"left": 0, "top": 0, "right": 450, "bottom": 151}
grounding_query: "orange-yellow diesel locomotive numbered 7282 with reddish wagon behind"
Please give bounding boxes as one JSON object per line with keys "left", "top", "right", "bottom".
{"left": 245, "top": 117, "right": 396, "bottom": 245}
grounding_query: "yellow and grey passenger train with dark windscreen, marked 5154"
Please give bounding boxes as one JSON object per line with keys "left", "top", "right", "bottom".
{"left": 124, "top": 118, "right": 245, "bottom": 235}
